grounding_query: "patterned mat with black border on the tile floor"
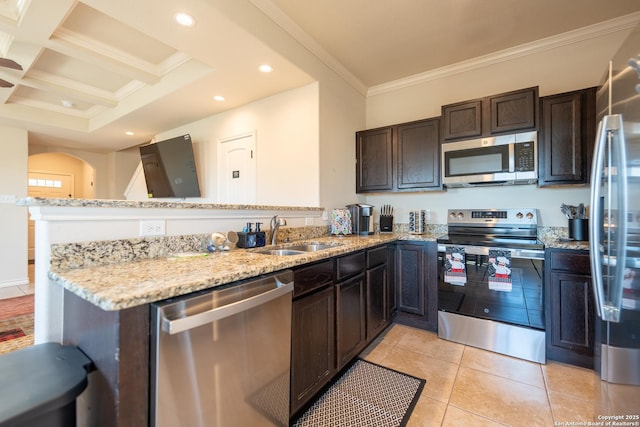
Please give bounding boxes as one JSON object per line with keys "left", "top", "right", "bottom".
{"left": 294, "top": 359, "right": 426, "bottom": 427}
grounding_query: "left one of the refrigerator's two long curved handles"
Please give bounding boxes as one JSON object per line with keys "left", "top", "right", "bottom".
{"left": 589, "top": 116, "right": 608, "bottom": 319}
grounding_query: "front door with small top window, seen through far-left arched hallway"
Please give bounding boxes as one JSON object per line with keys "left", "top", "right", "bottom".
{"left": 27, "top": 172, "right": 74, "bottom": 260}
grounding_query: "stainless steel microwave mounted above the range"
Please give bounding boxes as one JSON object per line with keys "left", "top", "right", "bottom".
{"left": 442, "top": 132, "right": 538, "bottom": 187}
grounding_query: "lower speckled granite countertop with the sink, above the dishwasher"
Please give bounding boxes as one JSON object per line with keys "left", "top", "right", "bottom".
{"left": 49, "top": 233, "right": 438, "bottom": 311}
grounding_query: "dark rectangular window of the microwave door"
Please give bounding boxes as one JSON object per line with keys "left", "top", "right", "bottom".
{"left": 445, "top": 145, "right": 509, "bottom": 176}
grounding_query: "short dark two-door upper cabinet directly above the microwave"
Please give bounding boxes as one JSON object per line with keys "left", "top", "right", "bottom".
{"left": 442, "top": 86, "right": 538, "bottom": 141}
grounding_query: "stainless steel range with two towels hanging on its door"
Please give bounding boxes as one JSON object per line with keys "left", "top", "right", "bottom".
{"left": 437, "top": 208, "right": 546, "bottom": 363}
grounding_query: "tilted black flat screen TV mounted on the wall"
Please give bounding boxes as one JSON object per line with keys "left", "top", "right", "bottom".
{"left": 140, "top": 134, "right": 200, "bottom": 198}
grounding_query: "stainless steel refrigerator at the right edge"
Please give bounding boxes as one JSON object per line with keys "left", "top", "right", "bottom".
{"left": 589, "top": 24, "right": 640, "bottom": 385}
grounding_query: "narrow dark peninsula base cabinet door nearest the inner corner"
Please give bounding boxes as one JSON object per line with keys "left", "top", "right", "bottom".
{"left": 366, "top": 264, "right": 389, "bottom": 342}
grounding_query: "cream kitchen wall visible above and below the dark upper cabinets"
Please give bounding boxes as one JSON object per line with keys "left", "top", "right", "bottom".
{"left": 364, "top": 23, "right": 628, "bottom": 227}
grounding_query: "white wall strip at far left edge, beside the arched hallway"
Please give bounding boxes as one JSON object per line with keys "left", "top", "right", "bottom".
{"left": 0, "top": 126, "right": 29, "bottom": 287}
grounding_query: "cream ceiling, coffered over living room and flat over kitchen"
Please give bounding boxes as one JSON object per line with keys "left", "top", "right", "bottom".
{"left": 0, "top": 0, "right": 640, "bottom": 152}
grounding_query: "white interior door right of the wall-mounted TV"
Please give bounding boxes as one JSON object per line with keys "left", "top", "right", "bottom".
{"left": 217, "top": 132, "right": 256, "bottom": 204}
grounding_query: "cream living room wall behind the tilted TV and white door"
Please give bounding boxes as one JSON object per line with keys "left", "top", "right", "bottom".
{"left": 130, "top": 83, "right": 320, "bottom": 207}
